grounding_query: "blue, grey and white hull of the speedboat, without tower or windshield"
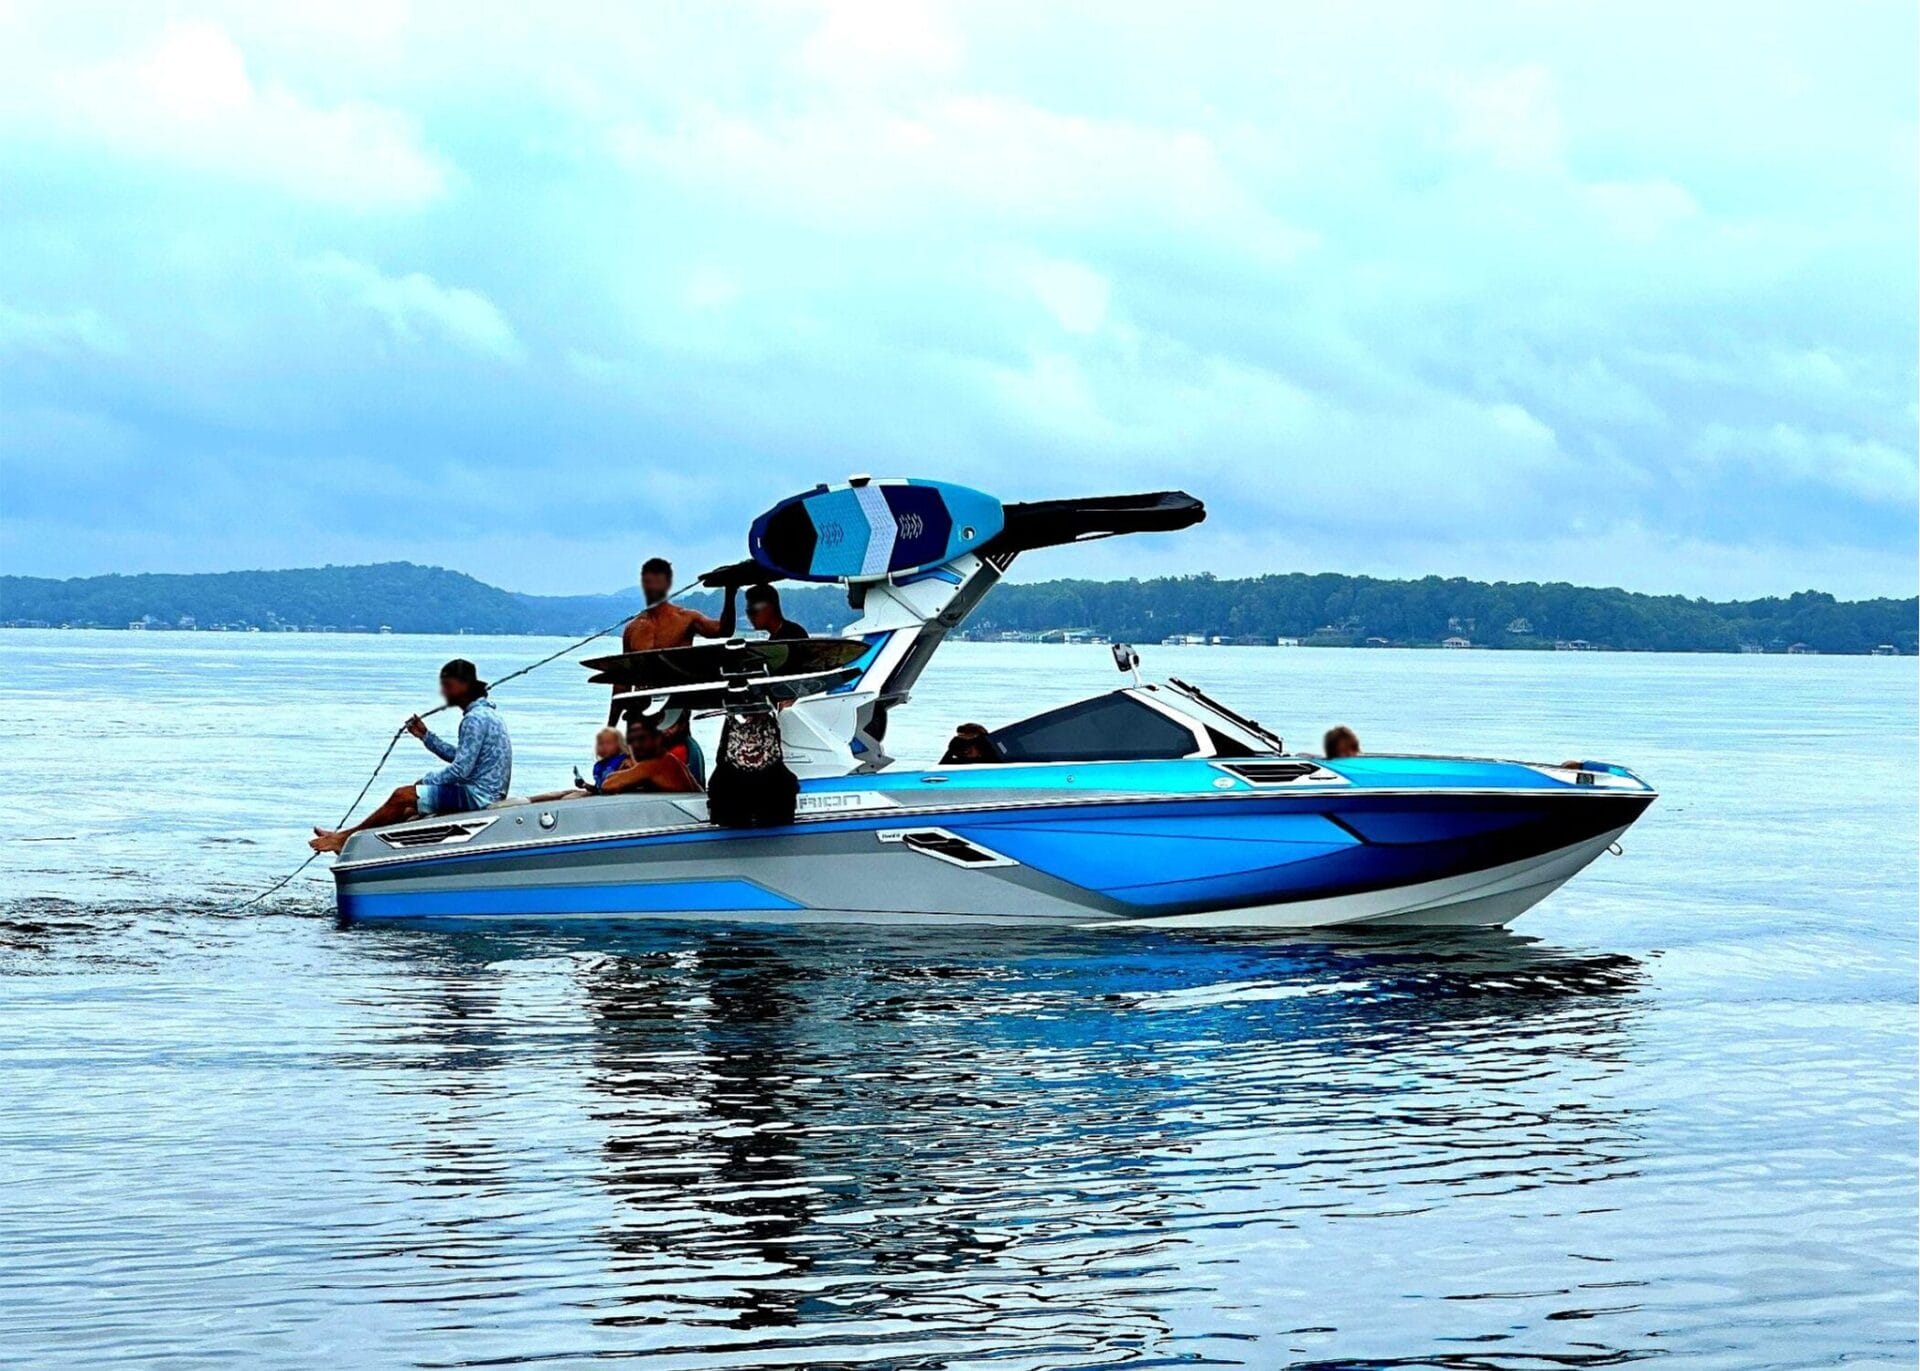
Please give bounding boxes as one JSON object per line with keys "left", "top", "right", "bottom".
{"left": 336, "top": 764, "right": 1653, "bottom": 927}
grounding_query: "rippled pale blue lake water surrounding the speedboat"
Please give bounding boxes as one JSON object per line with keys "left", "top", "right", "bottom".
{"left": 0, "top": 632, "right": 1916, "bottom": 1371}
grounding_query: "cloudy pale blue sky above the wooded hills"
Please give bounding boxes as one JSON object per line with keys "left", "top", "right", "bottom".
{"left": 0, "top": 0, "right": 1920, "bottom": 597}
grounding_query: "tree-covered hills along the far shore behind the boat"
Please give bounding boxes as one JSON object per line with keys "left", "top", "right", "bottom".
{"left": 0, "top": 563, "right": 1920, "bottom": 653}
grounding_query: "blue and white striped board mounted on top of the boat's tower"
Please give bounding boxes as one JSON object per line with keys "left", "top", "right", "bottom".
{"left": 747, "top": 478, "right": 1006, "bottom": 580}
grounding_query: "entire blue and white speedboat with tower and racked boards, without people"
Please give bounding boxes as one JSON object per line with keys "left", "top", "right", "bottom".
{"left": 334, "top": 480, "right": 1655, "bottom": 927}
